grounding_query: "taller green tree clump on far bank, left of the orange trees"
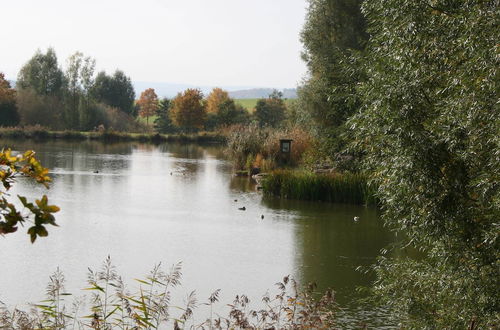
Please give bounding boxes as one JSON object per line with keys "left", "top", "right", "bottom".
{"left": 0, "top": 48, "right": 143, "bottom": 131}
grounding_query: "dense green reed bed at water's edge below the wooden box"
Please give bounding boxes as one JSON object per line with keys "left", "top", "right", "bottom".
{"left": 262, "top": 170, "right": 376, "bottom": 205}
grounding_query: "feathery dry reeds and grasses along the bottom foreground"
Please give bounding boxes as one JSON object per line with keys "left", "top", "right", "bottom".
{"left": 0, "top": 257, "right": 339, "bottom": 329}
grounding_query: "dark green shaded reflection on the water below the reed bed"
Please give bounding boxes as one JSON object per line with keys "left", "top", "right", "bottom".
{"left": 262, "top": 198, "right": 394, "bottom": 303}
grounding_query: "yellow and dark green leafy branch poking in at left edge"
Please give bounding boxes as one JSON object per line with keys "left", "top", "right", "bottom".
{"left": 0, "top": 149, "right": 59, "bottom": 243}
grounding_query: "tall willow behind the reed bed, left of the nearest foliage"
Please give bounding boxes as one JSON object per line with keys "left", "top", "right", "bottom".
{"left": 297, "top": 0, "right": 368, "bottom": 157}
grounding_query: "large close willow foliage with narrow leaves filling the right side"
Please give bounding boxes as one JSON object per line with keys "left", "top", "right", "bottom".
{"left": 349, "top": 0, "right": 500, "bottom": 329}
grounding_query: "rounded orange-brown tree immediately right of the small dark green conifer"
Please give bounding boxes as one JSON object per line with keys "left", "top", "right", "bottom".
{"left": 171, "top": 88, "right": 206, "bottom": 131}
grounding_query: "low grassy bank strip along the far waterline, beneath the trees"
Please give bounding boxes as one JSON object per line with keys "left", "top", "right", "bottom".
{"left": 0, "top": 126, "right": 226, "bottom": 143}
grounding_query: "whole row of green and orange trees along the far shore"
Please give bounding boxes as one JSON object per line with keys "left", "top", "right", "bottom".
{"left": 0, "top": 48, "right": 287, "bottom": 133}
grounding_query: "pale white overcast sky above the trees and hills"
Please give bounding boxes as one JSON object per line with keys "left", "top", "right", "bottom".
{"left": 0, "top": 0, "right": 306, "bottom": 88}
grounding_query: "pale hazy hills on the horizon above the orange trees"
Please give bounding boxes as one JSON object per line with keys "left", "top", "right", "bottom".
{"left": 132, "top": 81, "right": 297, "bottom": 99}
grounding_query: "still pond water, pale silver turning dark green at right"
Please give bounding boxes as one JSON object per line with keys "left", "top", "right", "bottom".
{"left": 0, "top": 140, "right": 394, "bottom": 323}
